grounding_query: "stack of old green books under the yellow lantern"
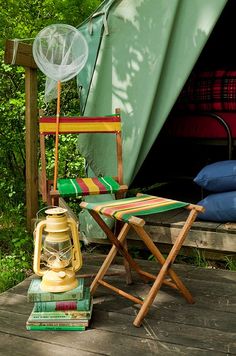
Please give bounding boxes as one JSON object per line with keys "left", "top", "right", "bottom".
{"left": 26, "top": 278, "right": 93, "bottom": 331}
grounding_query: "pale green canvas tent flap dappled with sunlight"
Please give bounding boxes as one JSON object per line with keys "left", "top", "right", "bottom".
{"left": 75, "top": 0, "right": 227, "bottom": 237}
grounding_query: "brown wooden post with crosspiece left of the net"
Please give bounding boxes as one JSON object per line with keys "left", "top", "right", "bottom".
{"left": 4, "top": 40, "right": 38, "bottom": 231}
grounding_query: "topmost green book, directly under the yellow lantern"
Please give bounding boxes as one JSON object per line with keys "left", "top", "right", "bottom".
{"left": 27, "top": 278, "right": 84, "bottom": 302}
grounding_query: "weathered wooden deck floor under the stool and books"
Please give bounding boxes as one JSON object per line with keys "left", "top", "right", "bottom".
{"left": 0, "top": 254, "right": 236, "bottom": 356}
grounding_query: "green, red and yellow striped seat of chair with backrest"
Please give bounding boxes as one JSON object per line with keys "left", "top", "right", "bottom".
{"left": 57, "top": 177, "right": 120, "bottom": 198}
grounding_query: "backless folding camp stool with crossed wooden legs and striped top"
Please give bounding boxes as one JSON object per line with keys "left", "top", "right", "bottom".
{"left": 80, "top": 194, "right": 204, "bottom": 326}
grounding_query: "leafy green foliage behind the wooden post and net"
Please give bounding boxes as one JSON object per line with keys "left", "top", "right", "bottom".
{"left": 0, "top": 0, "right": 101, "bottom": 292}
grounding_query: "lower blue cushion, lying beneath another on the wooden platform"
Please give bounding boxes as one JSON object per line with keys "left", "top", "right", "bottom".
{"left": 198, "top": 191, "right": 236, "bottom": 222}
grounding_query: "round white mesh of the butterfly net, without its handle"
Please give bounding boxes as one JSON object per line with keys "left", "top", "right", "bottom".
{"left": 33, "top": 24, "right": 88, "bottom": 98}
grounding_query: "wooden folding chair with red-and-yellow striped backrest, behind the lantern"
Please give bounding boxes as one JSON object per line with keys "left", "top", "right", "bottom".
{"left": 39, "top": 109, "right": 128, "bottom": 204}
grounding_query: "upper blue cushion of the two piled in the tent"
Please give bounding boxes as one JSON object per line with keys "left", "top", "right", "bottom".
{"left": 194, "top": 160, "right": 236, "bottom": 192}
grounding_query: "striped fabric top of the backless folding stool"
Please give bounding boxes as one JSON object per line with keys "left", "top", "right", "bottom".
{"left": 80, "top": 194, "right": 189, "bottom": 222}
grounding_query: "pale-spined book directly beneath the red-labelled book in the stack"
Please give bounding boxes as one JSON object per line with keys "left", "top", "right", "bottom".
{"left": 29, "top": 301, "right": 93, "bottom": 321}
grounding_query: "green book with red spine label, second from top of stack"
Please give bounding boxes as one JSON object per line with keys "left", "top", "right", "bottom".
{"left": 34, "top": 287, "right": 91, "bottom": 312}
